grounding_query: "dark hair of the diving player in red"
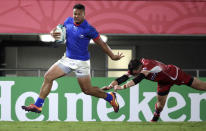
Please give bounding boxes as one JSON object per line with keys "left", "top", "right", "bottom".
{"left": 128, "top": 58, "right": 142, "bottom": 75}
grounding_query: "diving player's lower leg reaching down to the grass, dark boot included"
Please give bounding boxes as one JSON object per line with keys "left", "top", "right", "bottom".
{"left": 151, "top": 95, "right": 168, "bottom": 122}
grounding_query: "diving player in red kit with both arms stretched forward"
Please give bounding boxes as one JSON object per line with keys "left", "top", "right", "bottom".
{"left": 102, "top": 58, "right": 206, "bottom": 122}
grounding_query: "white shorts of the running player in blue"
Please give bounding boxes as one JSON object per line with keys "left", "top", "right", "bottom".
{"left": 56, "top": 56, "right": 90, "bottom": 77}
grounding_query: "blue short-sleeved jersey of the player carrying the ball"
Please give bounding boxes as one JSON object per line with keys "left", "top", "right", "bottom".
{"left": 64, "top": 17, "right": 99, "bottom": 61}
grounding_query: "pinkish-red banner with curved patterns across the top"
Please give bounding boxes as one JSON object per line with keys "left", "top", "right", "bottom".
{"left": 0, "top": 0, "right": 206, "bottom": 34}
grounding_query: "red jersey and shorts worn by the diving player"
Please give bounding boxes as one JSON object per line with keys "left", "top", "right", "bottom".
{"left": 128, "top": 58, "right": 193, "bottom": 95}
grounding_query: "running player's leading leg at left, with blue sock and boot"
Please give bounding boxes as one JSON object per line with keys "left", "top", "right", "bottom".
{"left": 22, "top": 64, "right": 65, "bottom": 113}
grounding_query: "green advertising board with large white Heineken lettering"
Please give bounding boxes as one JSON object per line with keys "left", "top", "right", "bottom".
{"left": 0, "top": 77, "right": 206, "bottom": 122}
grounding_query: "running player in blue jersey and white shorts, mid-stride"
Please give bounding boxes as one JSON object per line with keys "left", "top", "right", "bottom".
{"left": 22, "top": 4, "right": 124, "bottom": 113}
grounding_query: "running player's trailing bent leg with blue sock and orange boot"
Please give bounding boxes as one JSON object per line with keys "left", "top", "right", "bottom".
{"left": 78, "top": 75, "right": 119, "bottom": 112}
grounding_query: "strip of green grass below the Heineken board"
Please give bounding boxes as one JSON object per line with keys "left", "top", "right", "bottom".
{"left": 0, "top": 121, "right": 206, "bottom": 131}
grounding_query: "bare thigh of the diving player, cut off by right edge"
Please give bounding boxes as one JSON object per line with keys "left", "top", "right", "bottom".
{"left": 191, "top": 77, "right": 206, "bottom": 91}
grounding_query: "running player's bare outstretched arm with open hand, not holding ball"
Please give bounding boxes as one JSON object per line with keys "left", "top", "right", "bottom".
{"left": 94, "top": 38, "right": 124, "bottom": 60}
